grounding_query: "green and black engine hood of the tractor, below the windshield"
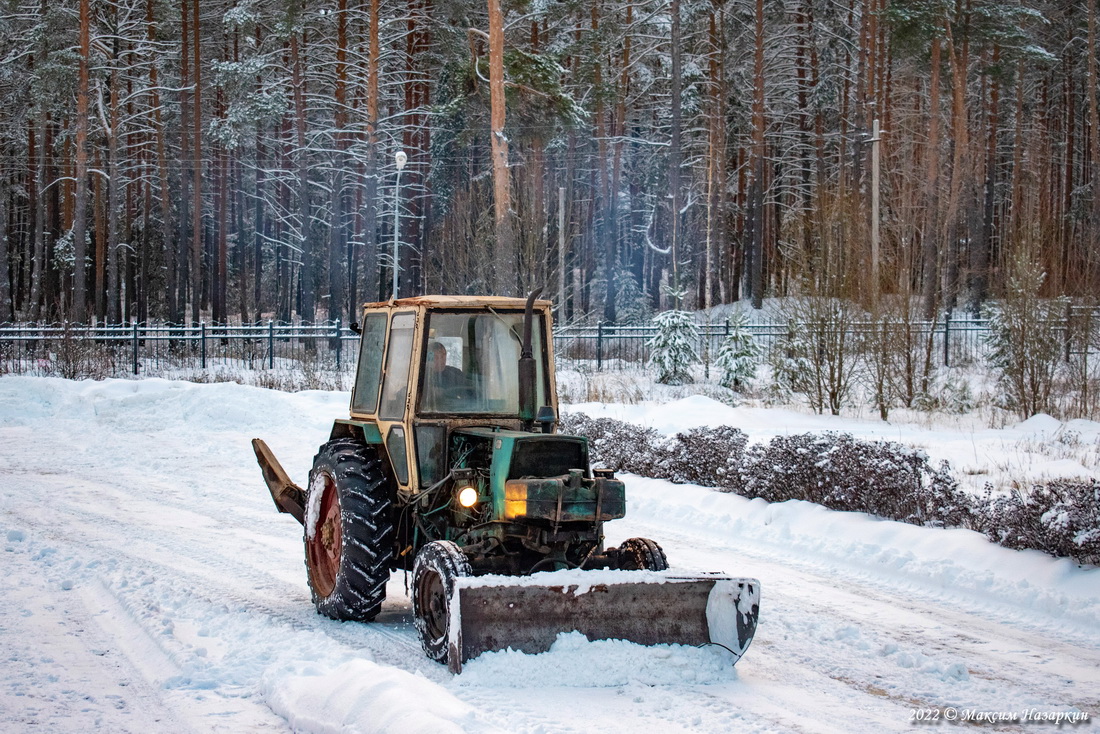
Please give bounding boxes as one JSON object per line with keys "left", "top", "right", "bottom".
{"left": 451, "top": 428, "right": 626, "bottom": 526}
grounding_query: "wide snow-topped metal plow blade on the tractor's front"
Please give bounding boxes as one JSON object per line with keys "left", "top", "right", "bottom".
{"left": 447, "top": 571, "right": 760, "bottom": 673}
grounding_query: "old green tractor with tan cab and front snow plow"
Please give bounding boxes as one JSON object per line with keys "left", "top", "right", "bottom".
{"left": 252, "top": 291, "right": 760, "bottom": 672}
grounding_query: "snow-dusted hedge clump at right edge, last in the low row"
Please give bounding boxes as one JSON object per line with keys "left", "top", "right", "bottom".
{"left": 982, "top": 479, "right": 1100, "bottom": 565}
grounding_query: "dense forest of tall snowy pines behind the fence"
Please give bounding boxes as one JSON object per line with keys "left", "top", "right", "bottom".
{"left": 0, "top": 0, "right": 1100, "bottom": 324}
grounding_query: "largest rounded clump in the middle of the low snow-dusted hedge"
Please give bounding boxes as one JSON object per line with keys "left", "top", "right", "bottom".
{"left": 743, "top": 432, "right": 971, "bottom": 526}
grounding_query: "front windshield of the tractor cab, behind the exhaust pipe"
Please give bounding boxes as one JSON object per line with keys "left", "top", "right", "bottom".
{"left": 420, "top": 311, "right": 546, "bottom": 415}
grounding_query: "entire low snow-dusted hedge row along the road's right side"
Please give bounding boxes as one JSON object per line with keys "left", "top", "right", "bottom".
{"left": 560, "top": 413, "right": 1100, "bottom": 563}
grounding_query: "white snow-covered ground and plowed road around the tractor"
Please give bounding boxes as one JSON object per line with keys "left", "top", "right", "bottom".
{"left": 0, "top": 377, "right": 1100, "bottom": 733}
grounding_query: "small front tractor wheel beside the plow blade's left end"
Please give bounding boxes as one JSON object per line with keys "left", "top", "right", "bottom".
{"left": 413, "top": 540, "right": 472, "bottom": 662}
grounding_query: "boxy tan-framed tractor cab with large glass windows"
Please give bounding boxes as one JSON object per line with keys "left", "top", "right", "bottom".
{"left": 338, "top": 296, "right": 558, "bottom": 494}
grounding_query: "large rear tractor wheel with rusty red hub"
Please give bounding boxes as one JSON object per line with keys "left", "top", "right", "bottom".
{"left": 305, "top": 438, "right": 394, "bottom": 622}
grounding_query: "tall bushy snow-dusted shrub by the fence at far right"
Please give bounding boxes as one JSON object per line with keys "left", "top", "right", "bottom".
{"left": 986, "top": 263, "right": 1065, "bottom": 418}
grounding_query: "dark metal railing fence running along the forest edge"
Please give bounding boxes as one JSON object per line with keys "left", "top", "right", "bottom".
{"left": 0, "top": 306, "right": 1100, "bottom": 377}
